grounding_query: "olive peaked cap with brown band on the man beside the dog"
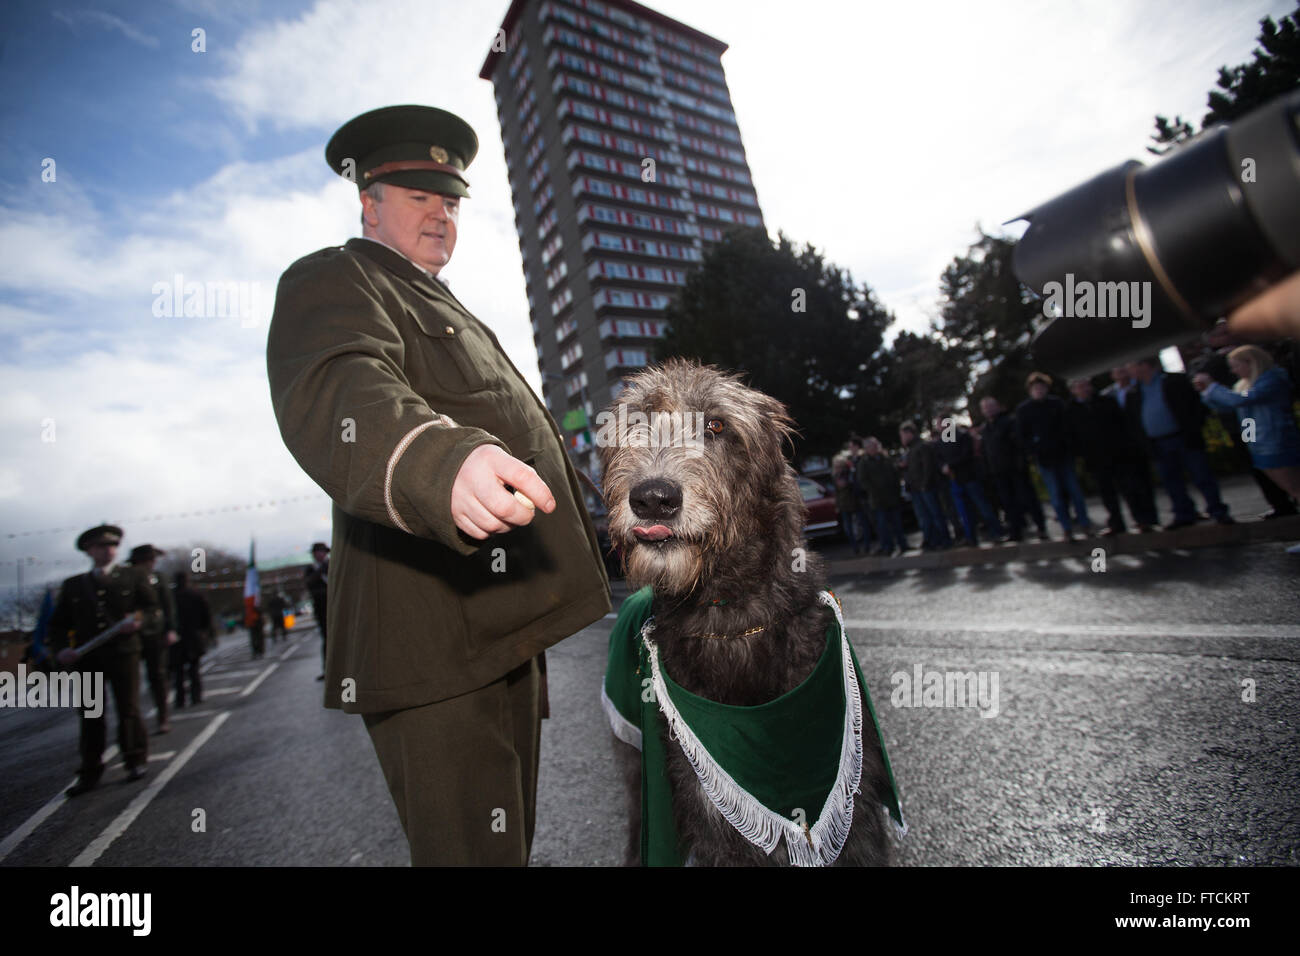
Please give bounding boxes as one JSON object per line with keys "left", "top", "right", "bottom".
{"left": 325, "top": 105, "right": 478, "bottom": 196}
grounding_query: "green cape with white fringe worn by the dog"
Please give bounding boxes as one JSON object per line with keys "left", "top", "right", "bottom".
{"left": 602, "top": 588, "right": 906, "bottom": 866}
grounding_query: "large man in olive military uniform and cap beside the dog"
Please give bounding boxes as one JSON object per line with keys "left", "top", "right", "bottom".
{"left": 267, "top": 107, "right": 610, "bottom": 865}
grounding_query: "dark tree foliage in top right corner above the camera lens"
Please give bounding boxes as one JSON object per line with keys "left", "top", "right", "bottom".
{"left": 1147, "top": 4, "right": 1300, "bottom": 156}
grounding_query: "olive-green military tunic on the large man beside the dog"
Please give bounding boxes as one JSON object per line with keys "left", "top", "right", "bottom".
{"left": 267, "top": 239, "right": 610, "bottom": 713}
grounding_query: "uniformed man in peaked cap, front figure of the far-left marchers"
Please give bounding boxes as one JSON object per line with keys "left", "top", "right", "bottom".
{"left": 49, "top": 524, "right": 159, "bottom": 796}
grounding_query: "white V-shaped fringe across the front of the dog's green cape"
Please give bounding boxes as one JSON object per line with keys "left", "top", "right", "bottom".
{"left": 641, "top": 591, "right": 862, "bottom": 866}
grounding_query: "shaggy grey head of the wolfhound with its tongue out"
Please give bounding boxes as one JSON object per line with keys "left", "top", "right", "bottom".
{"left": 595, "top": 359, "right": 803, "bottom": 594}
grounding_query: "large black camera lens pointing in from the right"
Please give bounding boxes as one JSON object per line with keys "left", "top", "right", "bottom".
{"left": 1014, "top": 92, "right": 1300, "bottom": 376}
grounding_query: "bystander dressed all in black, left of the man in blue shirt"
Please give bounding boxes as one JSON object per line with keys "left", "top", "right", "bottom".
{"left": 1066, "top": 378, "right": 1157, "bottom": 535}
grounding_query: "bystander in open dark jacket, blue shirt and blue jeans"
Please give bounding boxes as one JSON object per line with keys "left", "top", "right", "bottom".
{"left": 1125, "top": 356, "right": 1234, "bottom": 531}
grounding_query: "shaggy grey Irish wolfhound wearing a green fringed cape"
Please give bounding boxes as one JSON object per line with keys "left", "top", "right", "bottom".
{"left": 597, "top": 360, "right": 901, "bottom": 865}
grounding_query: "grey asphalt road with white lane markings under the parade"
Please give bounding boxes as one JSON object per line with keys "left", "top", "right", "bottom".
{"left": 0, "top": 545, "right": 1300, "bottom": 866}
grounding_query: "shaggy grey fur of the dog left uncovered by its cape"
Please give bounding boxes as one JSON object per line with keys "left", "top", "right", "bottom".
{"left": 598, "top": 360, "right": 889, "bottom": 866}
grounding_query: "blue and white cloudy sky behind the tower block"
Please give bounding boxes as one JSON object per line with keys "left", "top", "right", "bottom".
{"left": 0, "top": 0, "right": 1292, "bottom": 595}
